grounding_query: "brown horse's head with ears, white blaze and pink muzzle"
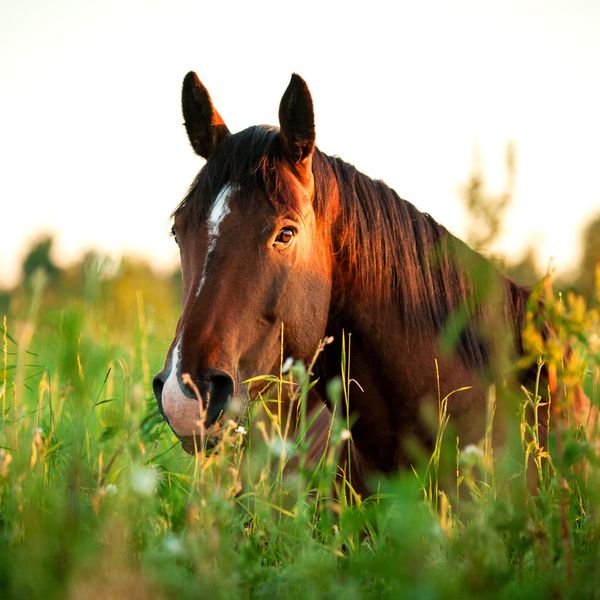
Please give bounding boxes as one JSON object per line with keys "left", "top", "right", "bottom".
{"left": 154, "top": 73, "right": 334, "bottom": 451}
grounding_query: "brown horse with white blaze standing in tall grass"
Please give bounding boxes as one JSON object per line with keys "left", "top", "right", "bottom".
{"left": 154, "top": 73, "right": 529, "bottom": 482}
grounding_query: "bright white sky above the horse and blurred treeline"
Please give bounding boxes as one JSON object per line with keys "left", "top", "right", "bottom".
{"left": 0, "top": 0, "right": 600, "bottom": 286}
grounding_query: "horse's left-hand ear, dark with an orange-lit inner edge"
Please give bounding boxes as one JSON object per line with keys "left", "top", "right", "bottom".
{"left": 181, "top": 71, "right": 229, "bottom": 158}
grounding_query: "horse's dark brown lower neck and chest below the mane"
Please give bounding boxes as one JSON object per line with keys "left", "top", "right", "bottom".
{"left": 323, "top": 244, "right": 526, "bottom": 472}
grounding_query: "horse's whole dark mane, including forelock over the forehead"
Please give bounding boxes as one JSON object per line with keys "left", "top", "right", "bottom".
{"left": 174, "top": 125, "right": 529, "bottom": 367}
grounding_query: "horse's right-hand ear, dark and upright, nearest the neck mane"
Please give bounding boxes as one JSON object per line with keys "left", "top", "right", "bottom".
{"left": 279, "top": 73, "right": 315, "bottom": 175}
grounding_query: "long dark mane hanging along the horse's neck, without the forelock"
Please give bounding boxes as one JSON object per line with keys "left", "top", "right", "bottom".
{"left": 322, "top": 153, "right": 530, "bottom": 368}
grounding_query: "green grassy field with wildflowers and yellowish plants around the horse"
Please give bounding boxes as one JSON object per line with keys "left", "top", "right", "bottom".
{"left": 0, "top": 261, "right": 600, "bottom": 600}
